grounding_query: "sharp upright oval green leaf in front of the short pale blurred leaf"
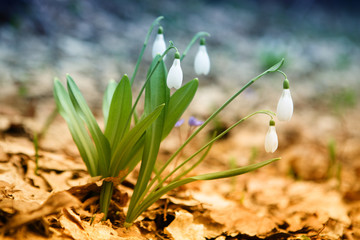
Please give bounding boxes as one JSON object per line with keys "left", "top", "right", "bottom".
{"left": 105, "top": 75, "right": 132, "bottom": 149}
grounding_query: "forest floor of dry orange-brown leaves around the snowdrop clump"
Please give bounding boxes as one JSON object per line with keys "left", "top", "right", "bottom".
{"left": 0, "top": 88, "right": 360, "bottom": 240}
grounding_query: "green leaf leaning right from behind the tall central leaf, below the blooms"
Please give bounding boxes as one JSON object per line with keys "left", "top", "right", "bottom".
{"left": 162, "top": 79, "right": 199, "bottom": 139}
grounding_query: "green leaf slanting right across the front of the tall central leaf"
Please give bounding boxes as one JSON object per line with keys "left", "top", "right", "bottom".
{"left": 110, "top": 104, "right": 164, "bottom": 177}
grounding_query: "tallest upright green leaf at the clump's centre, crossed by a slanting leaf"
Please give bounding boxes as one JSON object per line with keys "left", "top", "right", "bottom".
{"left": 129, "top": 56, "right": 170, "bottom": 214}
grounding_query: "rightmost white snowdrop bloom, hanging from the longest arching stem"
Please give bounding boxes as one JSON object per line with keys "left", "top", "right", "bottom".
{"left": 276, "top": 79, "right": 294, "bottom": 121}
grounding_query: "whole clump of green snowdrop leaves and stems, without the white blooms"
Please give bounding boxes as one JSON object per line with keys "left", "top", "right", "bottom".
{"left": 54, "top": 17, "right": 284, "bottom": 226}
